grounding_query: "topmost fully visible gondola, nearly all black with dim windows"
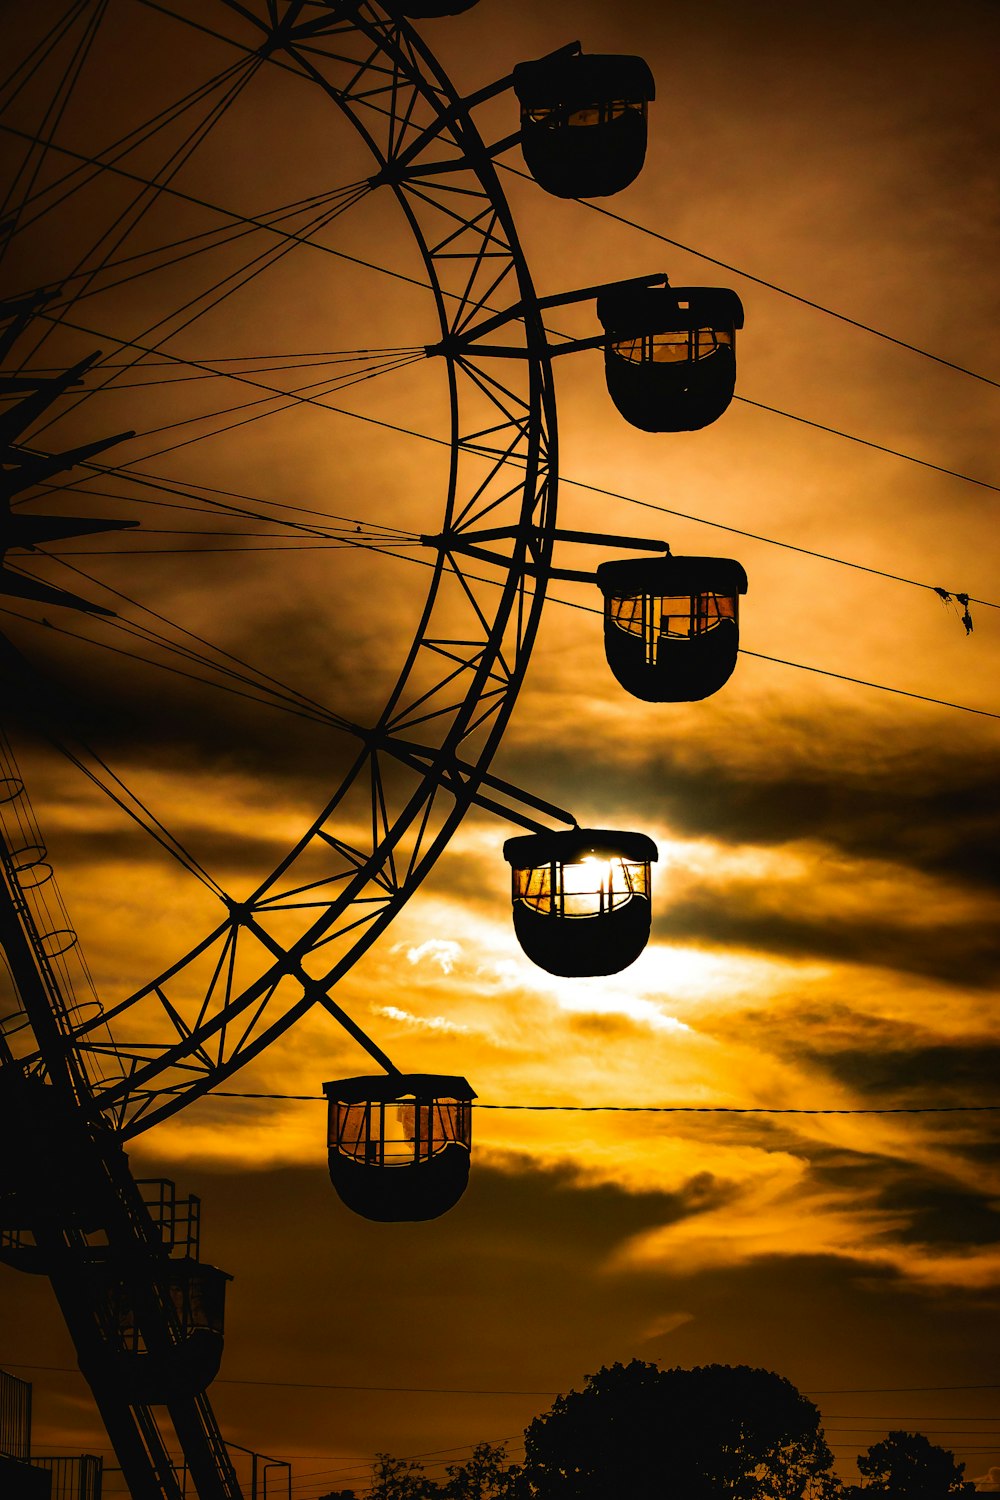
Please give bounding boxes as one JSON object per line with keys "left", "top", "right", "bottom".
{"left": 513, "top": 53, "right": 657, "bottom": 198}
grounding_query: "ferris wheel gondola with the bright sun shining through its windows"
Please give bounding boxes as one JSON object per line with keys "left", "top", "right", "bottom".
{"left": 504, "top": 828, "right": 657, "bottom": 978}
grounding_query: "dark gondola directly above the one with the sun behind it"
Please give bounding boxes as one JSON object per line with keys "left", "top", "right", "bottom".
{"left": 597, "top": 557, "right": 747, "bottom": 704}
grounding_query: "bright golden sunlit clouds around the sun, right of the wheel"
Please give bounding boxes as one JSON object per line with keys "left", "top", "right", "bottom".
{"left": 107, "top": 798, "right": 999, "bottom": 1326}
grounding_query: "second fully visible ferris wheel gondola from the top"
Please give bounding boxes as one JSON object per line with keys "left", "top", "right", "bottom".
{"left": 597, "top": 284, "right": 744, "bottom": 432}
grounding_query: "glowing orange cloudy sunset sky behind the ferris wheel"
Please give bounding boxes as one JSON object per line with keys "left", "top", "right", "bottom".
{"left": 0, "top": 0, "right": 1000, "bottom": 1500}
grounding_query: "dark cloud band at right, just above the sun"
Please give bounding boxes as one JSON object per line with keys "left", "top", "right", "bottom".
{"left": 507, "top": 711, "right": 1000, "bottom": 888}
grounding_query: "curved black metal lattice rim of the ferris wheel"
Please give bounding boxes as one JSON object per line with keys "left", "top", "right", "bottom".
{"left": 6, "top": 0, "right": 556, "bottom": 1137}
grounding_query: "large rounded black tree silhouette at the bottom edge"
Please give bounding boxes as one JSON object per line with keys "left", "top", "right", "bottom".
{"left": 523, "top": 1361, "right": 840, "bottom": 1500}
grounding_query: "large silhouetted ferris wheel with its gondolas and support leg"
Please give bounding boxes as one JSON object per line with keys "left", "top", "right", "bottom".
{"left": 0, "top": 0, "right": 747, "bottom": 1500}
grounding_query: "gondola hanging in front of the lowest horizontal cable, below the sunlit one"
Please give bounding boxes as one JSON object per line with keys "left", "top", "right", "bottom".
{"left": 322, "top": 1073, "right": 475, "bottom": 1223}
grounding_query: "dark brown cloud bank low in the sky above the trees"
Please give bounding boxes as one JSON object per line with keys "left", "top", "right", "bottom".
{"left": 9, "top": 1149, "right": 996, "bottom": 1482}
